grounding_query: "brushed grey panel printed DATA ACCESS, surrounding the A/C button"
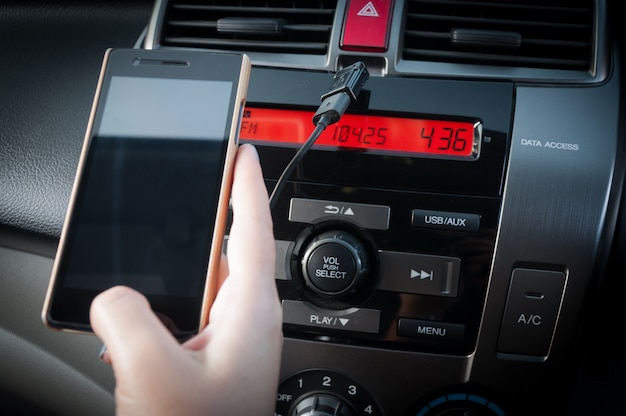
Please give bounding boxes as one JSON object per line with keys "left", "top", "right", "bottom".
{"left": 470, "top": 66, "right": 622, "bottom": 394}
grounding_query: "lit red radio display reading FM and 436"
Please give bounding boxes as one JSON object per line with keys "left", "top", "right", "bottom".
{"left": 240, "top": 107, "right": 482, "bottom": 160}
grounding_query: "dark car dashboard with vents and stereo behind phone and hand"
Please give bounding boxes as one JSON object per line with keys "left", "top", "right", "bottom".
{"left": 0, "top": 0, "right": 626, "bottom": 416}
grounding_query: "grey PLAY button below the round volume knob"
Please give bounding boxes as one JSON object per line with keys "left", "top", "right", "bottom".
{"left": 283, "top": 299, "right": 380, "bottom": 334}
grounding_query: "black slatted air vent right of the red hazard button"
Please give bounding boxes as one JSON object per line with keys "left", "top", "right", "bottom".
{"left": 402, "top": 0, "right": 595, "bottom": 71}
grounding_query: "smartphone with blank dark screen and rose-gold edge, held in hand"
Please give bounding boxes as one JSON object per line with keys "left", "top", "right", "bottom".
{"left": 42, "top": 49, "right": 250, "bottom": 339}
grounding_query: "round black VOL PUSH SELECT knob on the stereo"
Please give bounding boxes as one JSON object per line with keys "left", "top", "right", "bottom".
{"left": 301, "top": 231, "right": 369, "bottom": 295}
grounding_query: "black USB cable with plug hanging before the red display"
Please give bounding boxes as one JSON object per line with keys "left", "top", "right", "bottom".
{"left": 270, "top": 61, "right": 369, "bottom": 211}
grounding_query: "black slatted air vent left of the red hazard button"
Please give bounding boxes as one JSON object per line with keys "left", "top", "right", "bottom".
{"left": 161, "top": 0, "right": 337, "bottom": 55}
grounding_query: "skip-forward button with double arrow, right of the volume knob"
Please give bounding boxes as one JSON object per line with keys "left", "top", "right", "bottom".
{"left": 379, "top": 251, "right": 461, "bottom": 297}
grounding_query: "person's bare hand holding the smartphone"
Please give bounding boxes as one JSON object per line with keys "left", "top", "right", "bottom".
{"left": 91, "top": 145, "right": 282, "bottom": 416}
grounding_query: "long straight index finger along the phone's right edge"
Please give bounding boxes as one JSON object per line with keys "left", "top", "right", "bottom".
{"left": 207, "top": 145, "right": 282, "bottom": 354}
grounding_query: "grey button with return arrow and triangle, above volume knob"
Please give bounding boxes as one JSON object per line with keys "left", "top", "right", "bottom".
{"left": 289, "top": 198, "right": 391, "bottom": 230}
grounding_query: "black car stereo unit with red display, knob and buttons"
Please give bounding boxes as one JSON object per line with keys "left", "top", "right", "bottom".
{"left": 241, "top": 69, "right": 513, "bottom": 355}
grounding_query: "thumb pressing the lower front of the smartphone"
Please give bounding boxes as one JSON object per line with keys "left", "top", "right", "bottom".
{"left": 90, "top": 286, "right": 176, "bottom": 369}
